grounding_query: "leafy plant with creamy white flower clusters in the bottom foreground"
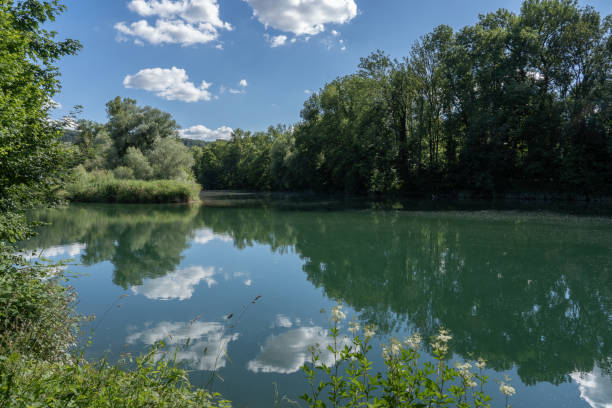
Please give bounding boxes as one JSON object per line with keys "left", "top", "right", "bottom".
{"left": 301, "top": 305, "right": 515, "bottom": 408}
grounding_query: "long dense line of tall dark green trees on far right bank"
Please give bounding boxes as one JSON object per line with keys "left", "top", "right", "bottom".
{"left": 196, "top": 0, "right": 612, "bottom": 195}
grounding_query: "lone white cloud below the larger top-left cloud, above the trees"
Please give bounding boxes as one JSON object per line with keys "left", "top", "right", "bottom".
{"left": 123, "top": 67, "right": 211, "bottom": 102}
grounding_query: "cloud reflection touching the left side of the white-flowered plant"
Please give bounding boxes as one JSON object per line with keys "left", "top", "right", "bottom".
{"left": 247, "top": 322, "right": 350, "bottom": 374}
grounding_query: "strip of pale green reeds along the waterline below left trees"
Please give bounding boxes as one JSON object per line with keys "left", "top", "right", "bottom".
{"left": 66, "top": 171, "right": 201, "bottom": 204}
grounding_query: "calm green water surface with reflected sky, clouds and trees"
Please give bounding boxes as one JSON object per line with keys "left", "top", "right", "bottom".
{"left": 25, "top": 197, "right": 612, "bottom": 408}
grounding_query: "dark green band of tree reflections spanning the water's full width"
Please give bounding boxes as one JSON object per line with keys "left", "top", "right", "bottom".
{"left": 24, "top": 200, "right": 612, "bottom": 384}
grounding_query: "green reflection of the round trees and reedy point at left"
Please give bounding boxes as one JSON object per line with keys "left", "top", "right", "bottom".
{"left": 26, "top": 205, "right": 198, "bottom": 288}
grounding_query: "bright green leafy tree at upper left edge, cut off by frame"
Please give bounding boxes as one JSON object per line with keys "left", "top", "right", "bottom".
{"left": 0, "top": 0, "right": 81, "bottom": 209}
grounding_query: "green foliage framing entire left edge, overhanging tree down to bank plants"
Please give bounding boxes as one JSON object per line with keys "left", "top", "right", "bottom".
{"left": 0, "top": 0, "right": 220, "bottom": 407}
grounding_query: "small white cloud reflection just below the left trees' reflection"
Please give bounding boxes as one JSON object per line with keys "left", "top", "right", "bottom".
{"left": 132, "top": 266, "right": 217, "bottom": 300}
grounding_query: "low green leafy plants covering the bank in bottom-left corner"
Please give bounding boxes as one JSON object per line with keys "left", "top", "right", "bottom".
{"left": 0, "top": 348, "right": 230, "bottom": 408}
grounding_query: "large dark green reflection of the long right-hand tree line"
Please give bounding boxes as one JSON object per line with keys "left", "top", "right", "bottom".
{"left": 198, "top": 209, "right": 612, "bottom": 384}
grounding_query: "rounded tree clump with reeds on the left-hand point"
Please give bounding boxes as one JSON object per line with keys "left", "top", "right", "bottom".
{"left": 62, "top": 97, "right": 201, "bottom": 203}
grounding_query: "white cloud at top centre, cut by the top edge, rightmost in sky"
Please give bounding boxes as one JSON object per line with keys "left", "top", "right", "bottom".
{"left": 245, "top": 0, "right": 357, "bottom": 35}
